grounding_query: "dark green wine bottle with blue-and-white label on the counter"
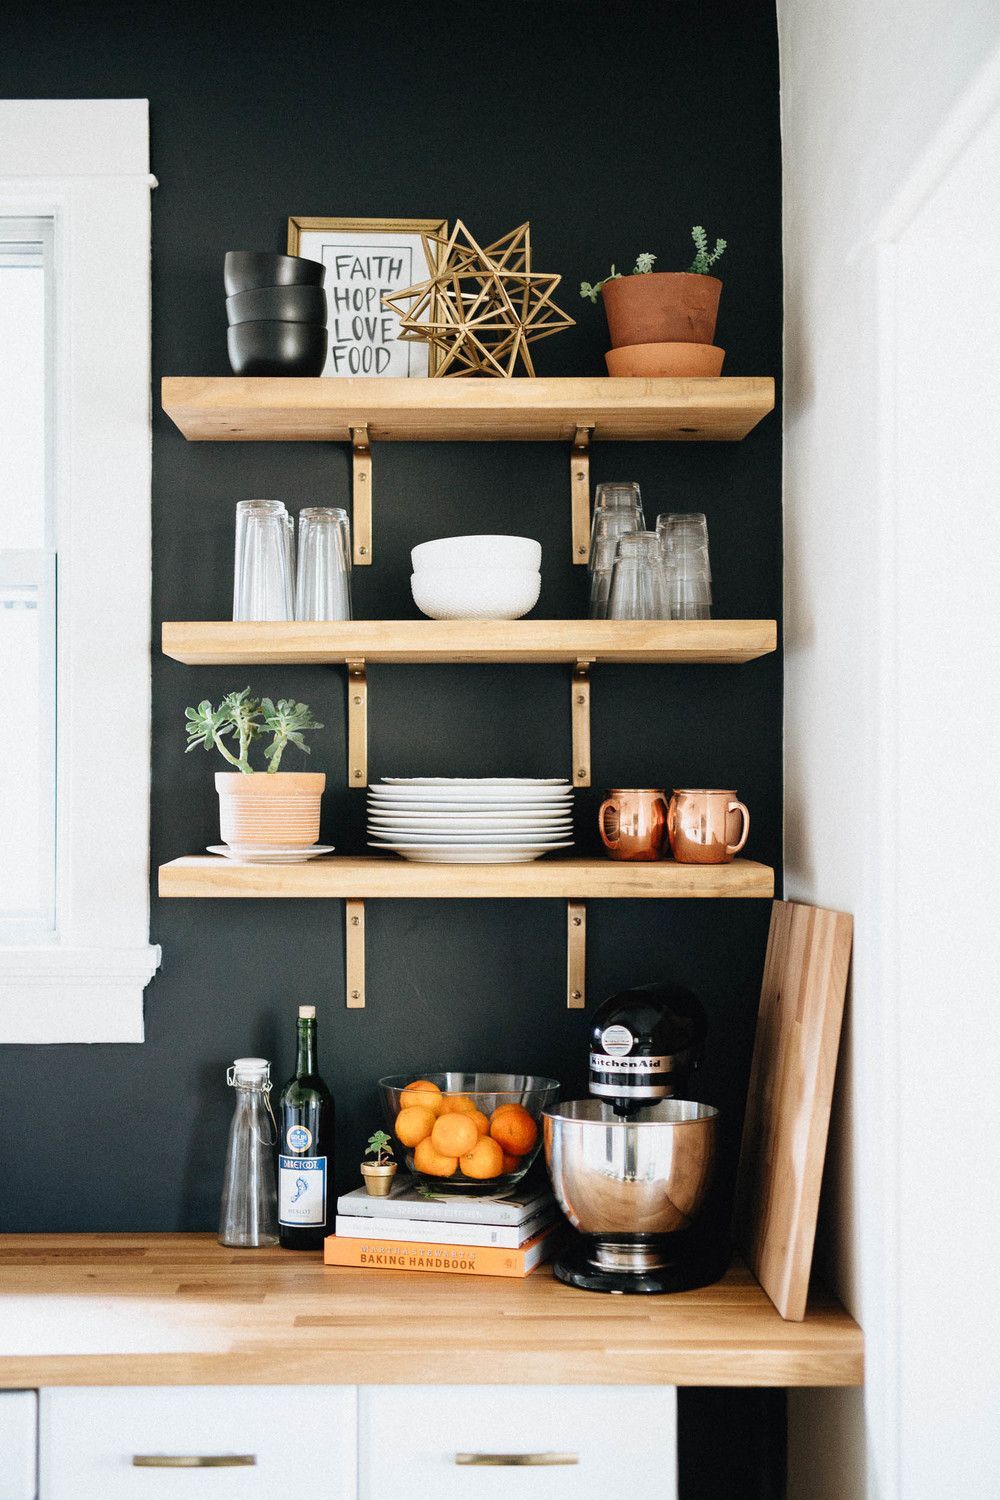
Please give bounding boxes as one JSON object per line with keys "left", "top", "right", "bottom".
{"left": 277, "top": 1005, "right": 334, "bottom": 1250}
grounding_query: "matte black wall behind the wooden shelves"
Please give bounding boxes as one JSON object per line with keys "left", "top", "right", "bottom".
{"left": 0, "top": 0, "right": 781, "bottom": 1497}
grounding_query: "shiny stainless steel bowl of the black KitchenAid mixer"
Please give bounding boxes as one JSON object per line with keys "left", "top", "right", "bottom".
{"left": 543, "top": 1100, "right": 718, "bottom": 1239}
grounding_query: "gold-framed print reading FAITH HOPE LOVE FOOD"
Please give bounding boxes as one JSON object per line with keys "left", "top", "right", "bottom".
{"left": 288, "top": 215, "right": 448, "bottom": 378}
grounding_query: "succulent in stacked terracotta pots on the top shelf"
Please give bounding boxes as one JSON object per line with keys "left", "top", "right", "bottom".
{"left": 580, "top": 224, "right": 726, "bottom": 375}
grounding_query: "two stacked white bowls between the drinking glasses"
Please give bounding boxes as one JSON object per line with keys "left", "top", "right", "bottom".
{"left": 409, "top": 537, "right": 541, "bottom": 620}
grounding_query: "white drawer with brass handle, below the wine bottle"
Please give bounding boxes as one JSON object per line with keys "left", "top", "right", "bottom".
{"left": 39, "top": 1386, "right": 357, "bottom": 1500}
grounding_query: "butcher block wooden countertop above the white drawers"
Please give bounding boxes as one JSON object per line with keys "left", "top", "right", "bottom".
{"left": 0, "top": 1235, "right": 864, "bottom": 1389}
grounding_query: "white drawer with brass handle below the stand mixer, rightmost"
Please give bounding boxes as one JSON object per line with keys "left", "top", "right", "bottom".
{"left": 358, "top": 1386, "right": 678, "bottom": 1500}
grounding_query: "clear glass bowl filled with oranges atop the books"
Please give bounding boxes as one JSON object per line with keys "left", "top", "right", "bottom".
{"left": 378, "top": 1073, "right": 559, "bottom": 1196}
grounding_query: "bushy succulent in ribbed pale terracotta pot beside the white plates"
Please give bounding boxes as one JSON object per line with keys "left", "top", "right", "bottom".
{"left": 184, "top": 687, "right": 327, "bottom": 849}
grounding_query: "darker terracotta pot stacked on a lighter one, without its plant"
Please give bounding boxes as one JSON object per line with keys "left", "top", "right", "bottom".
{"left": 601, "top": 272, "right": 723, "bottom": 350}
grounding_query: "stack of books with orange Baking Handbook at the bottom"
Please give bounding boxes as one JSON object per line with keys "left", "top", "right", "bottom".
{"left": 322, "top": 1175, "right": 562, "bottom": 1277}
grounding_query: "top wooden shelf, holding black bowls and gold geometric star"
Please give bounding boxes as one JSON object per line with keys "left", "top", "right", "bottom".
{"left": 162, "top": 375, "right": 774, "bottom": 443}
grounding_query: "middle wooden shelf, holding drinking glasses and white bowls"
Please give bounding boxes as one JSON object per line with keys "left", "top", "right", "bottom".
{"left": 163, "top": 620, "right": 778, "bottom": 666}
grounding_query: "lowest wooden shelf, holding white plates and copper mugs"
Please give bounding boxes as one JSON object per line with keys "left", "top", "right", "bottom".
{"left": 159, "top": 854, "right": 774, "bottom": 902}
